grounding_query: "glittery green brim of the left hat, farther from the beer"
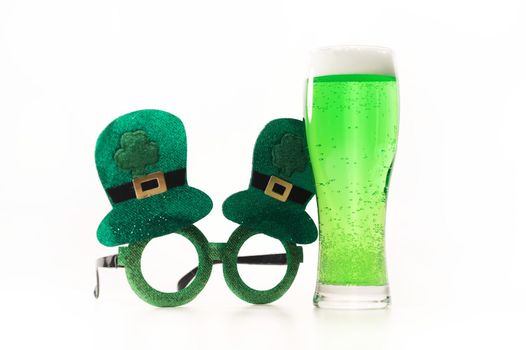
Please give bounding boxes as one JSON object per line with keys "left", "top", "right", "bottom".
{"left": 97, "top": 185, "right": 212, "bottom": 247}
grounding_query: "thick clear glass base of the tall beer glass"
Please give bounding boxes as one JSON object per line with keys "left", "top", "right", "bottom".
{"left": 314, "top": 283, "right": 390, "bottom": 310}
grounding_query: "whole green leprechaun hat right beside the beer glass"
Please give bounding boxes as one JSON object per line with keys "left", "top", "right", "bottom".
{"left": 223, "top": 119, "right": 318, "bottom": 244}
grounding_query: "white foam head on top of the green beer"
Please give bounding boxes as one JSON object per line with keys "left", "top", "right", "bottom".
{"left": 310, "top": 46, "right": 395, "bottom": 77}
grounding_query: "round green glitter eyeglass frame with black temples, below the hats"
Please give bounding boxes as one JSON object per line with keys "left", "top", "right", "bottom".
{"left": 95, "top": 225, "right": 303, "bottom": 307}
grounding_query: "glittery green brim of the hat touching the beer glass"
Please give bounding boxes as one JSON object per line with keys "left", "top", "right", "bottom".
{"left": 223, "top": 188, "right": 318, "bottom": 244}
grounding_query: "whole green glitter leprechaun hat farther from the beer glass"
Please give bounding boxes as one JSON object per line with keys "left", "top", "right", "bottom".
{"left": 95, "top": 110, "right": 212, "bottom": 246}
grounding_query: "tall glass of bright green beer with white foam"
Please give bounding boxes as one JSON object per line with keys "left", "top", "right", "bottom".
{"left": 305, "top": 46, "right": 399, "bottom": 309}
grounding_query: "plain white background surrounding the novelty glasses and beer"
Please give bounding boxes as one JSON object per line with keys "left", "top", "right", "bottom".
{"left": 0, "top": 0, "right": 526, "bottom": 350}
